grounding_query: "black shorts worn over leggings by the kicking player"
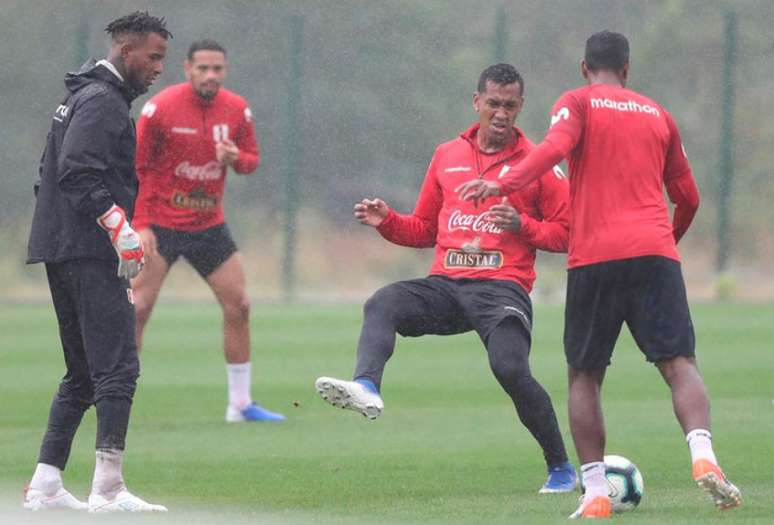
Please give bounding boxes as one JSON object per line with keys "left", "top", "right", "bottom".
{"left": 389, "top": 275, "right": 532, "bottom": 343}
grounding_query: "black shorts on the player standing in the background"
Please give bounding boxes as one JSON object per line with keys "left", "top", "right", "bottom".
{"left": 151, "top": 224, "right": 237, "bottom": 278}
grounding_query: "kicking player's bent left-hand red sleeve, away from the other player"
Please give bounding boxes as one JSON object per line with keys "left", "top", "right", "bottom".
{"left": 376, "top": 147, "right": 443, "bottom": 248}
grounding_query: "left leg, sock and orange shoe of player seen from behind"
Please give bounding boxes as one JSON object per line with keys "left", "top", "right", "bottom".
{"left": 568, "top": 367, "right": 611, "bottom": 518}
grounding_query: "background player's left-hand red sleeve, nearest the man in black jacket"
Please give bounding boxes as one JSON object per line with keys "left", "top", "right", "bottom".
{"left": 132, "top": 100, "right": 164, "bottom": 230}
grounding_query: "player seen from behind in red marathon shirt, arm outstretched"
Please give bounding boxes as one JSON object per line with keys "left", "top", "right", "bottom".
{"left": 458, "top": 31, "right": 741, "bottom": 517}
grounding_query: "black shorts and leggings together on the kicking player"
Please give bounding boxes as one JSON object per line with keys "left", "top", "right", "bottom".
{"left": 354, "top": 277, "right": 567, "bottom": 466}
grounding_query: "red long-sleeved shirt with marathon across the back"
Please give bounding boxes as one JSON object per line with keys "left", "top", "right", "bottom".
{"left": 500, "top": 84, "right": 699, "bottom": 268}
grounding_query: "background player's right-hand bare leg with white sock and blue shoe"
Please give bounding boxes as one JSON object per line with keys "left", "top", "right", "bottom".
{"left": 207, "top": 252, "right": 285, "bottom": 422}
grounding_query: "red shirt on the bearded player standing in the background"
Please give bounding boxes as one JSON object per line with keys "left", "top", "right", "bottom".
{"left": 132, "top": 82, "right": 260, "bottom": 231}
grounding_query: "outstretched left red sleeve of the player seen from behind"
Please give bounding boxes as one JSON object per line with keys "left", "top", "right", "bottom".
{"left": 499, "top": 91, "right": 586, "bottom": 195}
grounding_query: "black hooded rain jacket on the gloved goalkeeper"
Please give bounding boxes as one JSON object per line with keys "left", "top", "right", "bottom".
{"left": 27, "top": 60, "right": 138, "bottom": 263}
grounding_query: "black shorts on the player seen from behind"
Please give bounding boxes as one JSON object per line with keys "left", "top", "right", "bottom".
{"left": 564, "top": 256, "right": 695, "bottom": 370}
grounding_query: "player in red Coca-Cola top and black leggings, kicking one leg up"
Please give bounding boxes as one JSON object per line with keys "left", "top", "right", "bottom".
{"left": 316, "top": 64, "right": 577, "bottom": 493}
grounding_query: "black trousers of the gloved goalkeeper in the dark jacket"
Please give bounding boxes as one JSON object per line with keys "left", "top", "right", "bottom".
{"left": 38, "top": 259, "right": 140, "bottom": 469}
